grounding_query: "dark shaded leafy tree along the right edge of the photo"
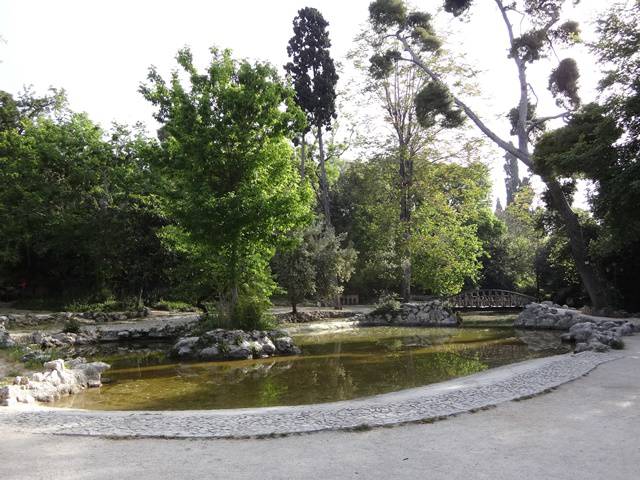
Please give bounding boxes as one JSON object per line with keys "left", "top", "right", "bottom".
{"left": 534, "top": 2, "right": 640, "bottom": 310}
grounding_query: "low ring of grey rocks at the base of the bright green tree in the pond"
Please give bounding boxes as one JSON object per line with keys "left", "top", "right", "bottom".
{"left": 171, "top": 328, "right": 300, "bottom": 360}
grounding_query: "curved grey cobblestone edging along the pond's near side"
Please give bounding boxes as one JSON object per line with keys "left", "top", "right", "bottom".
{"left": 0, "top": 352, "right": 623, "bottom": 438}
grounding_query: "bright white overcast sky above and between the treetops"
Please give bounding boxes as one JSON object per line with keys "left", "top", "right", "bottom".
{"left": 0, "top": 0, "right": 606, "bottom": 206}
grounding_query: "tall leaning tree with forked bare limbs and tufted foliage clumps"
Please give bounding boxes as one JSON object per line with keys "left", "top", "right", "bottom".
{"left": 369, "top": 0, "right": 607, "bottom": 308}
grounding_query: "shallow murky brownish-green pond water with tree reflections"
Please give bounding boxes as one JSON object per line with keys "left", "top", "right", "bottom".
{"left": 54, "top": 327, "right": 568, "bottom": 410}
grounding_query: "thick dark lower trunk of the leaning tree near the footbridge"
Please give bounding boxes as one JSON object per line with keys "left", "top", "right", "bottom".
{"left": 543, "top": 178, "right": 607, "bottom": 309}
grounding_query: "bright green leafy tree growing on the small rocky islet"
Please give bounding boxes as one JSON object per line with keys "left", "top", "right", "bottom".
{"left": 140, "top": 49, "right": 310, "bottom": 321}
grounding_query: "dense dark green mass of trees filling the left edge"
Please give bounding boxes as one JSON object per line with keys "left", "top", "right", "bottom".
{"left": 0, "top": 92, "right": 169, "bottom": 300}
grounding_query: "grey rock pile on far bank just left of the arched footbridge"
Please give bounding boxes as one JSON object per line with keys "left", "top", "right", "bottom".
{"left": 356, "top": 300, "right": 461, "bottom": 327}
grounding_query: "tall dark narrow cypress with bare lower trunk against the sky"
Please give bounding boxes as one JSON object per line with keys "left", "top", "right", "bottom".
{"left": 285, "top": 7, "right": 338, "bottom": 227}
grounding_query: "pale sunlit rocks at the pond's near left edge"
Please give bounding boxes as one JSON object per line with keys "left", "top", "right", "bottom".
{"left": 0, "top": 358, "right": 109, "bottom": 406}
